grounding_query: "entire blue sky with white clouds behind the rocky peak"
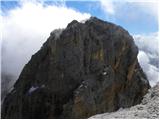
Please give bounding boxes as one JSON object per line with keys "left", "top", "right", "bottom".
{"left": 0, "top": 0, "right": 159, "bottom": 88}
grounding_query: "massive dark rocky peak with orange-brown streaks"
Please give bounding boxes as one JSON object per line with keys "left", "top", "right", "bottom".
{"left": 2, "top": 17, "right": 150, "bottom": 118}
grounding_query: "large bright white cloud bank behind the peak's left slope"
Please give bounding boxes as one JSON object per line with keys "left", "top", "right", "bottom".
{"left": 0, "top": 1, "right": 90, "bottom": 90}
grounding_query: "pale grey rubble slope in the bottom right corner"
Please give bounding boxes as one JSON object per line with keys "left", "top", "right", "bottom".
{"left": 90, "top": 84, "right": 159, "bottom": 119}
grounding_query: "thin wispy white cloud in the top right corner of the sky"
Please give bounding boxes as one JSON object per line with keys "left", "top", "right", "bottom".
{"left": 99, "top": 0, "right": 159, "bottom": 19}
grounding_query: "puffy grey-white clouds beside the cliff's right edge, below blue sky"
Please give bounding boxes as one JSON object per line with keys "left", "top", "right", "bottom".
{"left": 134, "top": 33, "right": 159, "bottom": 86}
